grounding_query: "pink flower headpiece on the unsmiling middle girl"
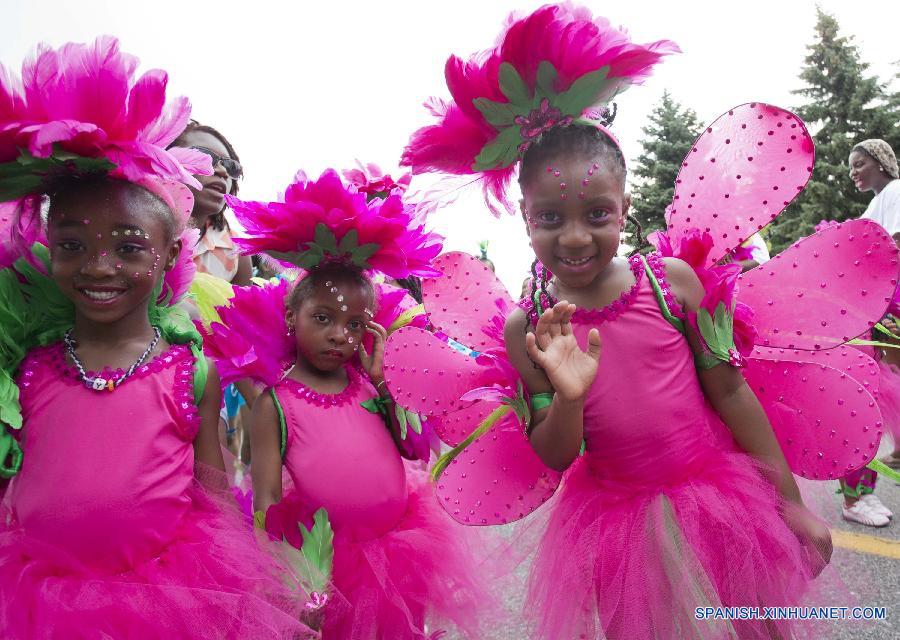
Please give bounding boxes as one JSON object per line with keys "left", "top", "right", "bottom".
{"left": 225, "top": 169, "right": 443, "bottom": 278}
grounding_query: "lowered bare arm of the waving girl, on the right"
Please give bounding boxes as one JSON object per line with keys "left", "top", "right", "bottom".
{"left": 665, "top": 258, "right": 831, "bottom": 562}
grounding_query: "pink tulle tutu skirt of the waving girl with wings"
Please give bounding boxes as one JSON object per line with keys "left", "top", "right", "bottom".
{"left": 526, "top": 451, "right": 821, "bottom": 640}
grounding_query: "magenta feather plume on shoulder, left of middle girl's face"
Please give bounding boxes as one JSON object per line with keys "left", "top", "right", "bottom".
{"left": 198, "top": 279, "right": 297, "bottom": 386}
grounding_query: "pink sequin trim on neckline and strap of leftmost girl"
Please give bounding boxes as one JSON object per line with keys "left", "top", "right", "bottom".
{"left": 19, "top": 342, "right": 200, "bottom": 441}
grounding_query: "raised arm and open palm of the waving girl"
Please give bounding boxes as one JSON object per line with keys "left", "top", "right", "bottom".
{"left": 504, "top": 301, "right": 600, "bottom": 471}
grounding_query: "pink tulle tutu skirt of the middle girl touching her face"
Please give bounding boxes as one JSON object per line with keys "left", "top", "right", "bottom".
{"left": 266, "top": 470, "right": 494, "bottom": 640}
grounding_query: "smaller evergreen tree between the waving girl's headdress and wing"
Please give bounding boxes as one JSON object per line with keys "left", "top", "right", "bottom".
{"left": 629, "top": 91, "right": 699, "bottom": 242}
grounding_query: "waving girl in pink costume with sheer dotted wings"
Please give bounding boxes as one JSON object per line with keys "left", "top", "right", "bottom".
{"left": 400, "top": 5, "right": 896, "bottom": 639}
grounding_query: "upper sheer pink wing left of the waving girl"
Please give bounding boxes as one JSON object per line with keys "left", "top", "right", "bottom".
{"left": 422, "top": 251, "right": 515, "bottom": 351}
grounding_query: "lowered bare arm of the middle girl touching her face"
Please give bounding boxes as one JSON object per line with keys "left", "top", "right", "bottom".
{"left": 250, "top": 393, "right": 281, "bottom": 513}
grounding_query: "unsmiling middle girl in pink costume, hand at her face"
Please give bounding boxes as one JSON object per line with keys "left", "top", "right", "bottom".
{"left": 203, "top": 170, "right": 481, "bottom": 640}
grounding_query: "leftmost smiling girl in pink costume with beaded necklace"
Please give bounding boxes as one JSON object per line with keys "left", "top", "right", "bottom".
{"left": 0, "top": 38, "right": 317, "bottom": 640}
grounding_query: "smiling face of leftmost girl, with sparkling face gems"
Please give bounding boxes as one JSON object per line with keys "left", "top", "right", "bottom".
{"left": 48, "top": 180, "right": 181, "bottom": 323}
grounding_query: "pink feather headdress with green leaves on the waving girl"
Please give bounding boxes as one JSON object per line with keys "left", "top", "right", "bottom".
{"left": 401, "top": 3, "right": 680, "bottom": 215}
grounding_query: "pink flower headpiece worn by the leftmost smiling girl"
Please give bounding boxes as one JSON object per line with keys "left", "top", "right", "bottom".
{"left": 0, "top": 36, "right": 212, "bottom": 228}
